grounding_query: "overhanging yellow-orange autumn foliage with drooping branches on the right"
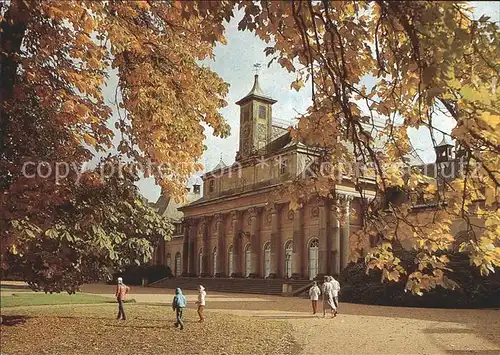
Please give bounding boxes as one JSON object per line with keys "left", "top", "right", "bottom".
{"left": 239, "top": 0, "right": 500, "bottom": 293}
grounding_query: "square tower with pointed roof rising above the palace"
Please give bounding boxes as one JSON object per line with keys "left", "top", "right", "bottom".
{"left": 236, "top": 74, "right": 276, "bottom": 160}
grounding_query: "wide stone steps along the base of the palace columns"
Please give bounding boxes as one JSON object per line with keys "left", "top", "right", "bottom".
{"left": 149, "top": 277, "right": 311, "bottom": 295}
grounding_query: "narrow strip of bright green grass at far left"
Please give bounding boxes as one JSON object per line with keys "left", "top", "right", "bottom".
{"left": 0, "top": 292, "right": 118, "bottom": 308}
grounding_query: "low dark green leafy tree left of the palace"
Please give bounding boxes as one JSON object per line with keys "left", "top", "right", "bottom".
{"left": 6, "top": 158, "right": 172, "bottom": 293}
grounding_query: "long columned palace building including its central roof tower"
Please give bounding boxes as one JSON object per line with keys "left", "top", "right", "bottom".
{"left": 154, "top": 75, "right": 476, "bottom": 280}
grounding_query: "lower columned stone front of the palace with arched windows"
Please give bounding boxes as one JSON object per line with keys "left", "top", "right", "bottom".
{"left": 177, "top": 188, "right": 360, "bottom": 278}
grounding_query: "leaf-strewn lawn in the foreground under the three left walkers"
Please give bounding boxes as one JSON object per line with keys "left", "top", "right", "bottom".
{"left": 0, "top": 303, "right": 298, "bottom": 354}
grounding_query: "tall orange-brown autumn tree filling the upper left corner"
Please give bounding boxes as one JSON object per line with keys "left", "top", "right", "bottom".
{"left": 0, "top": 0, "right": 232, "bottom": 290}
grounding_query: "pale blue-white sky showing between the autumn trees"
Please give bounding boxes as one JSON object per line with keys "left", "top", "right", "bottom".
{"left": 114, "top": 1, "right": 500, "bottom": 201}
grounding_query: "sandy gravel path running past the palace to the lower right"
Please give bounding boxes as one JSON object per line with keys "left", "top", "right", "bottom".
{"left": 80, "top": 285, "right": 500, "bottom": 355}
